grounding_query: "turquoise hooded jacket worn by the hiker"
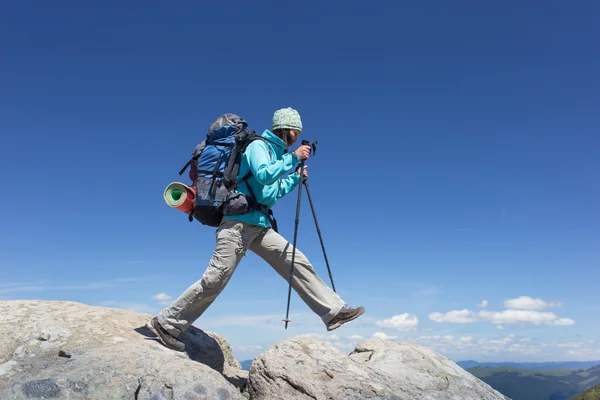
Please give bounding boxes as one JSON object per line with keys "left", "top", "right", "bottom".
{"left": 223, "top": 129, "right": 300, "bottom": 228}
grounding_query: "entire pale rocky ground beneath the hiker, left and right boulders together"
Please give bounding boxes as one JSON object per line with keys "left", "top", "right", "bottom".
{"left": 0, "top": 300, "right": 507, "bottom": 400}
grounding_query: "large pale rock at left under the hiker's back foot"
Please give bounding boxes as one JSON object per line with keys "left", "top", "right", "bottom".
{"left": 0, "top": 301, "right": 246, "bottom": 400}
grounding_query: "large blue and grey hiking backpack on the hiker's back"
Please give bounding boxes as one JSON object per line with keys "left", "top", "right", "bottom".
{"left": 179, "top": 114, "right": 276, "bottom": 229}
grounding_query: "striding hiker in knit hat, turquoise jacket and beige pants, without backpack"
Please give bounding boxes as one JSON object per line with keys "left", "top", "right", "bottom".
{"left": 148, "top": 108, "right": 365, "bottom": 351}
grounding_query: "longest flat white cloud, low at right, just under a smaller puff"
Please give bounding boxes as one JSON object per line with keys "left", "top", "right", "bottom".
{"left": 429, "top": 309, "right": 575, "bottom": 329}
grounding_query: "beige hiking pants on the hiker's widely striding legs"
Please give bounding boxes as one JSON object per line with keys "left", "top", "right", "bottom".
{"left": 157, "top": 219, "right": 344, "bottom": 337}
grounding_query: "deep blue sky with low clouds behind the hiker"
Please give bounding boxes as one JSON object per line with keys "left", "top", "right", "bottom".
{"left": 0, "top": 1, "right": 600, "bottom": 361}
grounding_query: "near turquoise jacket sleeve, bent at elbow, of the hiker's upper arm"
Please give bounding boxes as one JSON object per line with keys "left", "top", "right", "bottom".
{"left": 244, "top": 140, "right": 300, "bottom": 185}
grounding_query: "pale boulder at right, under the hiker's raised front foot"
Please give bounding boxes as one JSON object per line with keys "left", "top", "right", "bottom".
{"left": 248, "top": 337, "right": 505, "bottom": 400}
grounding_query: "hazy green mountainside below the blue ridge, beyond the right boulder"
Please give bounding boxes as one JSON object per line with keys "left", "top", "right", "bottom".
{"left": 467, "top": 366, "right": 600, "bottom": 400}
